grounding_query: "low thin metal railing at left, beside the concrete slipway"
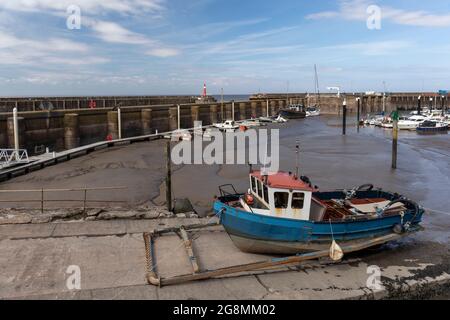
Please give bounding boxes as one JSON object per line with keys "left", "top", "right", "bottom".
{"left": 0, "top": 187, "right": 128, "bottom": 213}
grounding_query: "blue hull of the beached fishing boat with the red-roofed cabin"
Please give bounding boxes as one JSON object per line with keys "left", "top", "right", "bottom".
{"left": 214, "top": 201, "right": 423, "bottom": 254}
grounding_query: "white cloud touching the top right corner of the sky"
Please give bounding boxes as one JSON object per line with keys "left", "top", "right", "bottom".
{"left": 306, "top": 0, "right": 450, "bottom": 27}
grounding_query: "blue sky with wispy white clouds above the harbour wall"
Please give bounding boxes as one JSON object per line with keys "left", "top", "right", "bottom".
{"left": 0, "top": 0, "right": 450, "bottom": 96}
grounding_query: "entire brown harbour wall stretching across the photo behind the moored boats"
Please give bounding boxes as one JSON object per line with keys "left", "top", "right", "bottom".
{"left": 0, "top": 94, "right": 441, "bottom": 154}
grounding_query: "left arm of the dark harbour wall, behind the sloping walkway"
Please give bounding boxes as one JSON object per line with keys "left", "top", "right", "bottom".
{"left": 0, "top": 100, "right": 286, "bottom": 154}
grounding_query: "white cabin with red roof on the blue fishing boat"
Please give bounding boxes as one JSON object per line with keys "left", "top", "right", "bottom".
{"left": 241, "top": 171, "right": 317, "bottom": 220}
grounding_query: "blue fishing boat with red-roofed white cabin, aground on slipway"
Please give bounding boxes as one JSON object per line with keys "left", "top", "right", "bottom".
{"left": 214, "top": 171, "right": 424, "bottom": 254}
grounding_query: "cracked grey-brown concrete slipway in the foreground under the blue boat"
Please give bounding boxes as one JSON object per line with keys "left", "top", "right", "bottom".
{"left": 0, "top": 219, "right": 450, "bottom": 300}
